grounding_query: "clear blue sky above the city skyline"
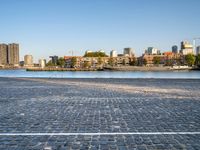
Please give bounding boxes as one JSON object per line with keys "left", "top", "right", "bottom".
{"left": 0, "top": 0, "right": 200, "bottom": 62}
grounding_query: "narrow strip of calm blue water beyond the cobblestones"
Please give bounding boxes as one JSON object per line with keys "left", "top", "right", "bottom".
{"left": 0, "top": 70, "right": 200, "bottom": 79}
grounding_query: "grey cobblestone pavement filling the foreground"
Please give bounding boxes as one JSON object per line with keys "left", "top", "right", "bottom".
{"left": 0, "top": 78, "right": 200, "bottom": 150}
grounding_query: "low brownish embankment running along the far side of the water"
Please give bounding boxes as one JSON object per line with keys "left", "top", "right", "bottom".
{"left": 26, "top": 66, "right": 200, "bottom": 71}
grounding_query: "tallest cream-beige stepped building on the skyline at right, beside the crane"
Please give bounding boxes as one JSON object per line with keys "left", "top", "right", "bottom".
{"left": 180, "top": 41, "right": 194, "bottom": 55}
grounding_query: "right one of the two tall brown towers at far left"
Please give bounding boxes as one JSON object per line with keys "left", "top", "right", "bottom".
{"left": 8, "top": 43, "right": 19, "bottom": 66}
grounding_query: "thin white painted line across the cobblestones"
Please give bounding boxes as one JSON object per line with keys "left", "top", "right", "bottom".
{"left": 0, "top": 132, "right": 200, "bottom": 136}
